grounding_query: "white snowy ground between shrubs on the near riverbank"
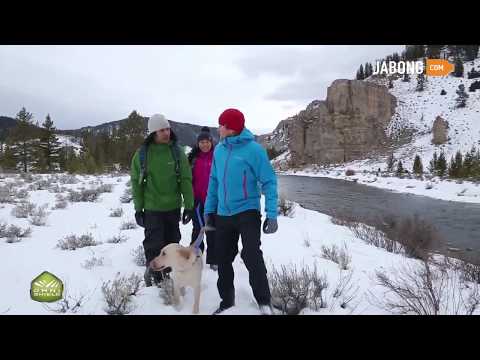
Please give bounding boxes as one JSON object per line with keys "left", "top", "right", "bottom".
{"left": 0, "top": 176, "right": 480, "bottom": 315}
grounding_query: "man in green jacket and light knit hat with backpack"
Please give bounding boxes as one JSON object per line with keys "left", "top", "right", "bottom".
{"left": 131, "top": 114, "right": 193, "bottom": 286}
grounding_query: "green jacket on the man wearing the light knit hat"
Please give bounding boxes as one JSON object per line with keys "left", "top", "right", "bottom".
{"left": 130, "top": 142, "right": 193, "bottom": 211}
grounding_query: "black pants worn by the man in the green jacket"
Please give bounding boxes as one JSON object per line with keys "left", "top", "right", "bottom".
{"left": 143, "top": 209, "right": 181, "bottom": 272}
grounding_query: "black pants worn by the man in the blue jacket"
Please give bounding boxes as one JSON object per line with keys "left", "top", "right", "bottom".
{"left": 216, "top": 210, "right": 271, "bottom": 307}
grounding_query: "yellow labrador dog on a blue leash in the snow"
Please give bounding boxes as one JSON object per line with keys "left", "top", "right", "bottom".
{"left": 150, "top": 239, "right": 203, "bottom": 314}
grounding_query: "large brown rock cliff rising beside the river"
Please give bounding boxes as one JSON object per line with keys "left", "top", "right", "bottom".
{"left": 282, "top": 80, "right": 396, "bottom": 166}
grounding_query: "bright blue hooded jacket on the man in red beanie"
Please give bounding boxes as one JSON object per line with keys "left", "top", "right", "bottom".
{"left": 204, "top": 128, "right": 278, "bottom": 219}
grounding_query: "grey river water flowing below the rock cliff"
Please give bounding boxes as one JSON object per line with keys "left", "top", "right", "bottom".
{"left": 278, "top": 175, "right": 480, "bottom": 259}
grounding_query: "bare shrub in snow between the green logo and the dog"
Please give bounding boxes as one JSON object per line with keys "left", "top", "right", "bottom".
{"left": 102, "top": 274, "right": 142, "bottom": 315}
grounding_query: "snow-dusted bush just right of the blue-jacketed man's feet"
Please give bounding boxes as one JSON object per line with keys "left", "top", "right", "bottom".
{"left": 268, "top": 265, "right": 328, "bottom": 315}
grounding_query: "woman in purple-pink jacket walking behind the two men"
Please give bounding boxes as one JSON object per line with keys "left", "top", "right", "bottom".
{"left": 188, "top": 126, "right": 218, "bottom": 271}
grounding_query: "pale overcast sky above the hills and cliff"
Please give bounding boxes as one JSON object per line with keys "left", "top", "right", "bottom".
{"left": 0, "top": 45, "right": 404, "bottom": 134}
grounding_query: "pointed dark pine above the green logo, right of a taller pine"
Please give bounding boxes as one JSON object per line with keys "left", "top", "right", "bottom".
{"left": 35, "top": 115, "right": 61, "bottom": 172}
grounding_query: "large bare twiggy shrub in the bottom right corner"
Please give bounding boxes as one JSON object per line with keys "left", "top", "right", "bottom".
{"left": 376, "top": 261, "right": 480, "bottom": 315}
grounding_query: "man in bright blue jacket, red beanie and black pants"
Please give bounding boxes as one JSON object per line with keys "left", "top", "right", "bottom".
{"left": 204, "top": 109, "right": 278, "bottom": 314}
